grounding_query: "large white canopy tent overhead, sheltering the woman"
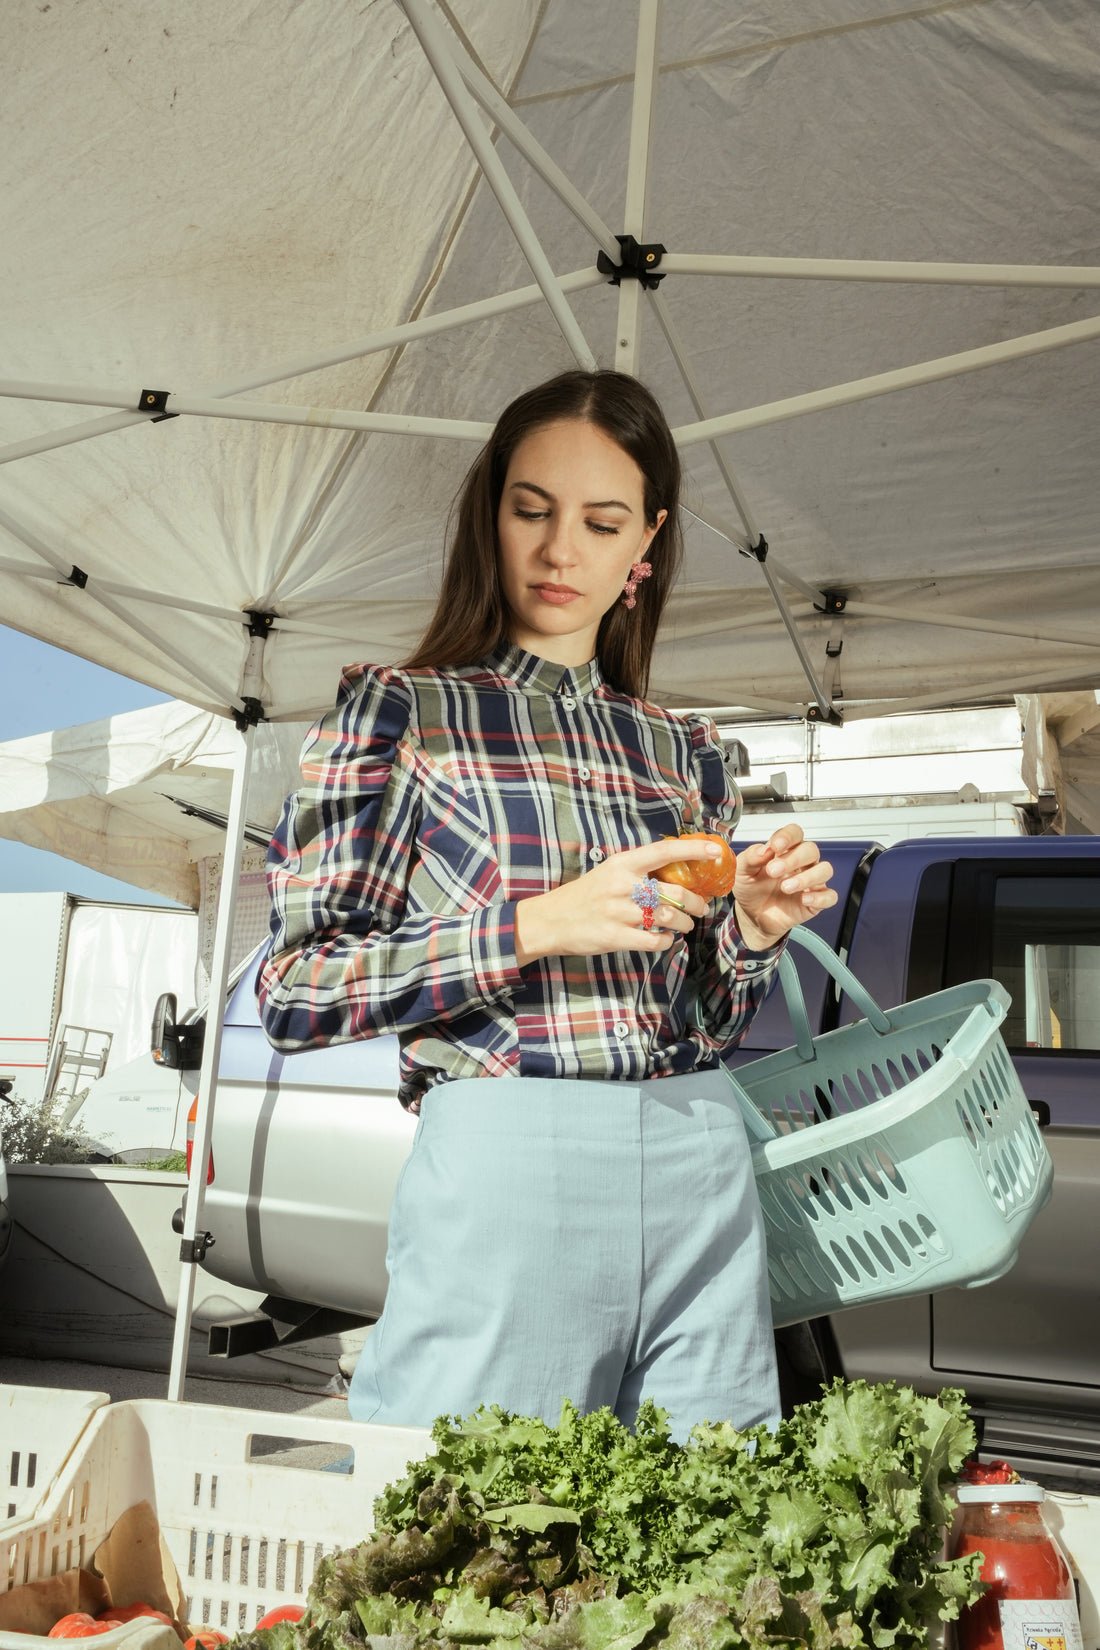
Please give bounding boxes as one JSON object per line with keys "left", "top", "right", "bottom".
{"left": 0, "top": 0, "right": 1100, "bottom": 1391}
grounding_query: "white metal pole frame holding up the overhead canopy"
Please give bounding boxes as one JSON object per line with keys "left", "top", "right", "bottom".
{"left": 0, "top": 0, "right": 1100, "bottom": 1398}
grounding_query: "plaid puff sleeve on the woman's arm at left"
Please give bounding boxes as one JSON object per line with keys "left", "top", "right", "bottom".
{"left": 257, "top": 667, "right": 521, "bottom": 1053}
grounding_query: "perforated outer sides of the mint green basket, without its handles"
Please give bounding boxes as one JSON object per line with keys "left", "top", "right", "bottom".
{"left": 754, "top": 1013, "right": 1052, "bottom": 1325}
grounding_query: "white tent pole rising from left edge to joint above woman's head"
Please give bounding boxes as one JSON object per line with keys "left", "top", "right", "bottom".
{"left": 0, "top": 264, "right": 607, "bottom": 464}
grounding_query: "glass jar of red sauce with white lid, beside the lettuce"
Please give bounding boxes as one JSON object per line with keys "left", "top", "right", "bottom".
{"left": 953, "top": 1483, "right": 1082, "bottom": 1650}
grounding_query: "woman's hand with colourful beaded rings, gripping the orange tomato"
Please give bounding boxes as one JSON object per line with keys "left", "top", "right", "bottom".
{"left": 516, "top": 840, "right": 721, "bottom": 969}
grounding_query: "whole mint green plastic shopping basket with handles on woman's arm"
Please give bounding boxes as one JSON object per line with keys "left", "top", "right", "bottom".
{"left": 729, "top": 927, "right": 1054, "bottom": 1327}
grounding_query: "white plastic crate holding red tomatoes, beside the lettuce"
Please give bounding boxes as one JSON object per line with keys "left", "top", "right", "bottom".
{"left": 0, "top": 1399, "right": 430, "bottom": 1650}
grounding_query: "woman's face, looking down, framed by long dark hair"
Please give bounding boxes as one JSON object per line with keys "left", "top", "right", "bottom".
{"left": 496, "top": 419, "right": 666, "bottom": 665}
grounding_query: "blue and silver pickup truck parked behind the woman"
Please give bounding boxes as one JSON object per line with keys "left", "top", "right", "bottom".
{"left": 94, "top": 837, "right": 1100, "bottom": 1487}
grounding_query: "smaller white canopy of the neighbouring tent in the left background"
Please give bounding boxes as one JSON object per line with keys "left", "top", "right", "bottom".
{"left": 0, "top": 703, "right": 305, "bottom": 909}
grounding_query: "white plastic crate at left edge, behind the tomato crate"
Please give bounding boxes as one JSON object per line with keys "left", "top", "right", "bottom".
{"left": 0, "top": 1386, "right": 110, "bottom": 1530}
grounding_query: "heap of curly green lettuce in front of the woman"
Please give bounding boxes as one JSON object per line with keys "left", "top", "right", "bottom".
{"left": 234, "top": 1381, "right": 983, "bottom": 1650}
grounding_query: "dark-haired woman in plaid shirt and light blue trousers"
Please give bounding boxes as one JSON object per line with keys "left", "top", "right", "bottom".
{"left": 259, "top": 371, "right": 836, "bottom": 1437}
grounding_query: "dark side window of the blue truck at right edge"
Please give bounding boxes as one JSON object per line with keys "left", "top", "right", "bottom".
{"left": 991, "top": 876, "right": 1100, "bottom": 1049}
